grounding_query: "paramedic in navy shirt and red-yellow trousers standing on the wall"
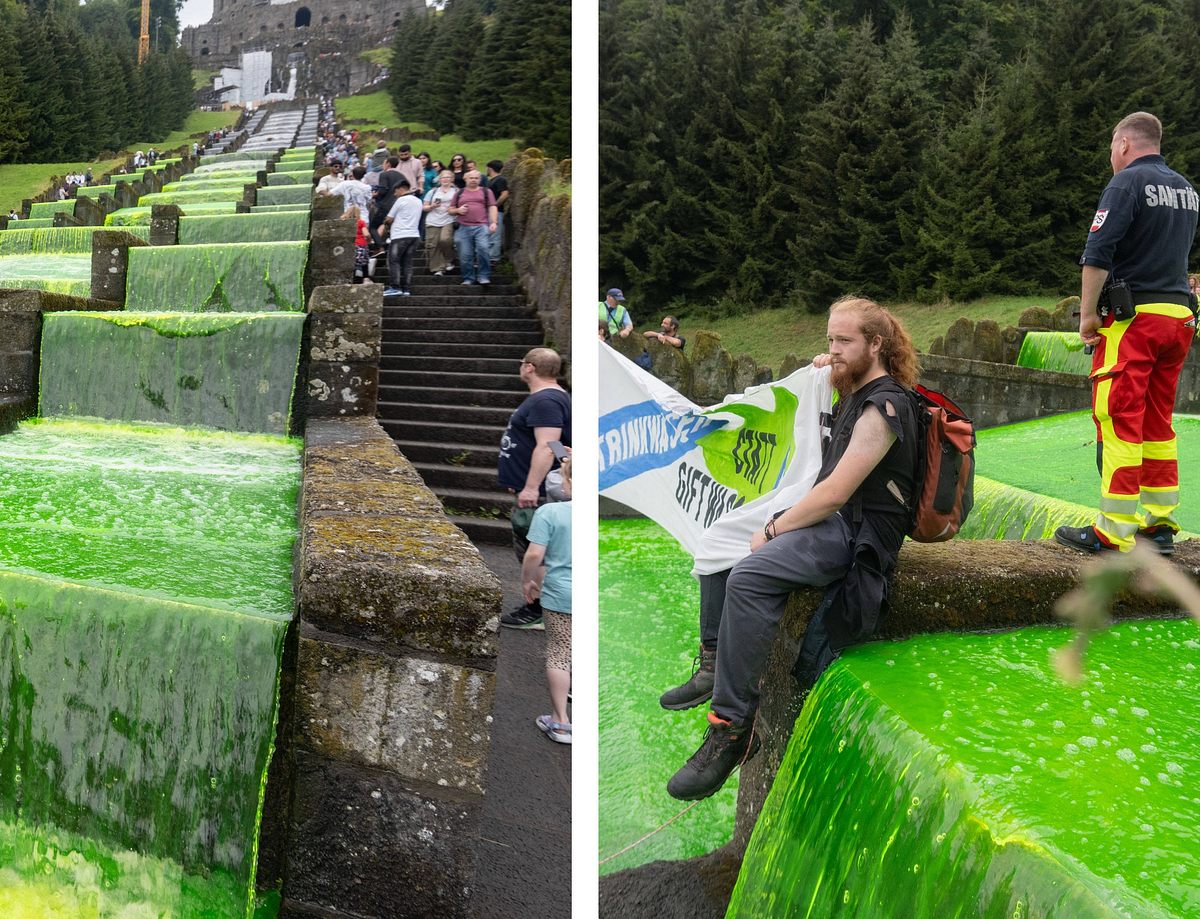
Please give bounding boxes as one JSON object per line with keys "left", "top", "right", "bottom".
{"left": 1055, "top": 112, "right": 1200, "bottom": 555}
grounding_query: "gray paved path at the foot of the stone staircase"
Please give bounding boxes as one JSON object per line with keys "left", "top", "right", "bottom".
{"left": 475, "top": 546, "right": 571, "bottom": 919}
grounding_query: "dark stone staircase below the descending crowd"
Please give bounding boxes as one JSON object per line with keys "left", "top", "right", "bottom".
{"left": 372, "top": 253, "right": 542, "bottom": 545}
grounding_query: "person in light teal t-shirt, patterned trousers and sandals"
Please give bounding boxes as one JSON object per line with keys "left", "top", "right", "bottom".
{"left": 521, "top": 456, "right": 571, "bottom": 744}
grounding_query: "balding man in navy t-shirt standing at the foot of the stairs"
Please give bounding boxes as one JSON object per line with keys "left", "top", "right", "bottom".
{"left": 496, "top": 350, "right": 571, "bottom": 630}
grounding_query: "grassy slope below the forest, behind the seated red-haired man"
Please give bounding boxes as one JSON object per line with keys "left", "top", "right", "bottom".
{"left": 672, "top": 292, "right": 1070, "bottom": 368}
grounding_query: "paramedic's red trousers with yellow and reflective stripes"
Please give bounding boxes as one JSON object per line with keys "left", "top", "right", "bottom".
{"left": 1092, "top": 304, "right": 1195, "bottom": 551}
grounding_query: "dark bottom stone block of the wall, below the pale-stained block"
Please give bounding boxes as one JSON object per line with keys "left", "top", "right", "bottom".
{"left": 283, "top": 755, "right": 481, "bottom": 919}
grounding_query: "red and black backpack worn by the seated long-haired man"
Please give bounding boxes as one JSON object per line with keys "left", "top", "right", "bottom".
{"left": 908, "top": 384, "right": 976, "bottom": 542}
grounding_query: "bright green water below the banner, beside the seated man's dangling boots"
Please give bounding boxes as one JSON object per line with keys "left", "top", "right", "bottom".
{"left": 599, "top": 519, "right": 737, "bottom": 875}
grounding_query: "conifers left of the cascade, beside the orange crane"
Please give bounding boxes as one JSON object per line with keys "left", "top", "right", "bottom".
{"left": 0, "top": 0, "right": 193, "bottom": 163}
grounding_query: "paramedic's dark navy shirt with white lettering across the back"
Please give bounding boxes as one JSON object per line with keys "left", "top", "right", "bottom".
{"left": 1079, "top": 154, "right": 1200, "bottom": 294}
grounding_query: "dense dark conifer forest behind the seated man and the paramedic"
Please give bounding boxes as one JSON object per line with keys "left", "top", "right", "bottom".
{"left": 599, "top": 0, "right": 1200, "bottom": 314}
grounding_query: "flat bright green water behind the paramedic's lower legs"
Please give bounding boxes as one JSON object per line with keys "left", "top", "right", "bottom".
{"left": 972, "top": 412, "right": 1200, "bottom": 533}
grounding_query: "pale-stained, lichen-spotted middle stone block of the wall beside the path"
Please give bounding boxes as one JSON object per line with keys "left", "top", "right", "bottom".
{"left": 295, "top": 635, "right": 496, "bottom": 795}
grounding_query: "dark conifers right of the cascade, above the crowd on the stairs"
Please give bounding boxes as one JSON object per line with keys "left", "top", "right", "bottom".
{"left": 389, "top": 0, "right": 571, "bottom": 157}
